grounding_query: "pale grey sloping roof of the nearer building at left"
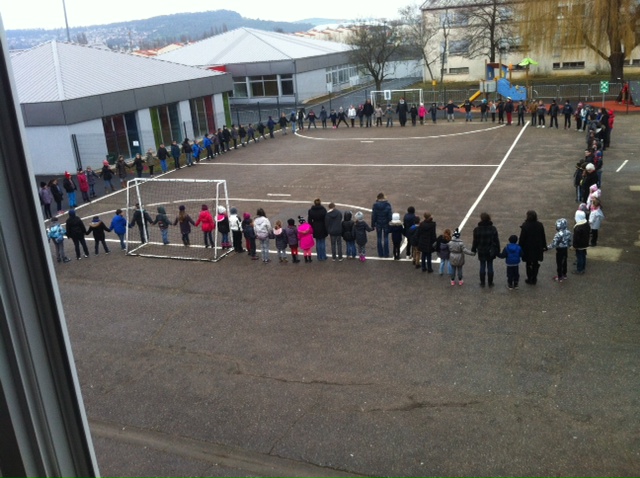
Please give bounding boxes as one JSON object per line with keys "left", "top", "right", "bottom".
{"left": 11, "top": 41, "right": 228, "bottom": 104}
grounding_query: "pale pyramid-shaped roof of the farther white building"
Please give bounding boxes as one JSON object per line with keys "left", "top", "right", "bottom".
{"left": 158, "top": 28, "right": 351, "bottom": 67}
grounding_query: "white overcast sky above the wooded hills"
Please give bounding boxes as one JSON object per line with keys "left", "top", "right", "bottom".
{"left": 0, "top": 0, "right": 410, "bottom": 30}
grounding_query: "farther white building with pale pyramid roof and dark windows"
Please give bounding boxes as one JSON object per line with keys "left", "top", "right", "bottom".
{"left": 158, "top": 28, "right": 360, "bottom": 104}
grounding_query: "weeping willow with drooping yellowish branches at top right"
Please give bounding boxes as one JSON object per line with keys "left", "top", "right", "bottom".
{"left": 519, "top": 0, "right": 640, "bottom": 81}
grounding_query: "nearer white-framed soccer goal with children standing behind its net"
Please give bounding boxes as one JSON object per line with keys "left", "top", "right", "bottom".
{"left": 126, "top": 178, "right": 233, "bottom": 262}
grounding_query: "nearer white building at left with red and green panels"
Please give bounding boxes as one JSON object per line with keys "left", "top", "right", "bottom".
{"left": 11, "top": 41, "right": 233, "bottom": 174}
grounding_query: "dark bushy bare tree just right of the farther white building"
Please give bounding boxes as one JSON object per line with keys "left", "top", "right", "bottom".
{"left": 346, "top": 20, "right": 401, "bottom": 90}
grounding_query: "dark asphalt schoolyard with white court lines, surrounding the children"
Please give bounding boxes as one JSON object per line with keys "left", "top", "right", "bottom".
{"left": 54, "top": 114, "right": 640, "bottom": 478}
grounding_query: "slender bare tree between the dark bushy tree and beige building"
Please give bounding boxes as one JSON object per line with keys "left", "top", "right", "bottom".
{"left": 398, "top": 4, "right": 439, "bottom": 80}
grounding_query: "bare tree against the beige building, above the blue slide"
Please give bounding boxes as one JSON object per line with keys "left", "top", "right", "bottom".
{"left": 456, "top": 0, "right": 513, "bottom": 63}
